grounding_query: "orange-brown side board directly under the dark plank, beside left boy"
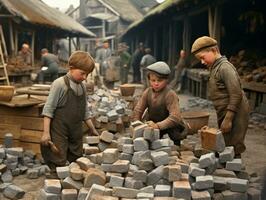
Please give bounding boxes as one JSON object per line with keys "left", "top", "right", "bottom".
{"left": 0, "top": 115, "right": 43, "bottom": 131}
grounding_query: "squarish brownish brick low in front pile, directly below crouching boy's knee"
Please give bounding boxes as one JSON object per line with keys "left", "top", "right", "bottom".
{"left": 163, "top": 165, "right": 182, "bottom": 182}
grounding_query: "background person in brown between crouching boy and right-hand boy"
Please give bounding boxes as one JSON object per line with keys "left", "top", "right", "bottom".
{"left": 170, "top": 49, "right": 187, "bottom": 92}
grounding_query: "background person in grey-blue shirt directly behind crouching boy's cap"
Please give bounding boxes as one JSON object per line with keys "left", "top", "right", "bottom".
{"left": 140, "top": 47, "right": 156, "bottom": 88}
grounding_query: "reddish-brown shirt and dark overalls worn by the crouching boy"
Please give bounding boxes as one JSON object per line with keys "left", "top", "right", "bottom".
{"left": 133, "top": 87, "right": 184, "bottom": 145}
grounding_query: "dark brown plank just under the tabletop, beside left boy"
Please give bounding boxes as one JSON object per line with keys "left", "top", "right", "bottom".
{"left": 0, "top": 105, "right": 42, "bottom": 117}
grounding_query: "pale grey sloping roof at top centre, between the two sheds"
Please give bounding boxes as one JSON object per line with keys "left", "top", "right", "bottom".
{"left": 102, "top": 0, "right": 143, "bottom": 22}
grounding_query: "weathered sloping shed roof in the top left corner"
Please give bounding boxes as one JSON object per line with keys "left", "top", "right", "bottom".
{"left": 0, "top": 0, "right": 95, "bottom": 37}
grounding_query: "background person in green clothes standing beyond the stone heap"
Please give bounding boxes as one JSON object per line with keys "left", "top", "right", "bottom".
{"left": 117, "top": 43, "right": 131, "bottom": 84}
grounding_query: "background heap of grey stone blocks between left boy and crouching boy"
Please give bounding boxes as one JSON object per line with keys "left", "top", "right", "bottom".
{"left": 88, "top": 89, "right": 132, "bottom": 132}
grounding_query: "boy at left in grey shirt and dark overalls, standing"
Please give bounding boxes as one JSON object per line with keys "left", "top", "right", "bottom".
{"left": 41, "top": 51, "right": 98, "bottom": 171}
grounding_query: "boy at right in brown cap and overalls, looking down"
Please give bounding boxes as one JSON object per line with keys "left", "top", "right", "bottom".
{"left": 191, "top": 36, "right": 249, "bottom": 157}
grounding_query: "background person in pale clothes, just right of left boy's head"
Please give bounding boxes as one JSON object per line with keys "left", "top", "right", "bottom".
{"left": 95, "top": 40, "right": 112, "bottom": 76}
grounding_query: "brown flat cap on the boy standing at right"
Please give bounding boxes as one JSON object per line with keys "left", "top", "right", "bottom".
{"left": 191, "top": 36, "right": 217, "bottom": 54}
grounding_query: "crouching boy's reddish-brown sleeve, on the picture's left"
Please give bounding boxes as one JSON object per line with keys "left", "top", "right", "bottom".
{"left": 133, "top": 89, "right": 149, "bottom": 121}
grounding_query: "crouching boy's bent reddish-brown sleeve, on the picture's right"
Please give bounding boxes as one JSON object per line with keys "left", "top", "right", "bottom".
{"left": 157, "top": 91, "right": 181, "bottom": 130}
